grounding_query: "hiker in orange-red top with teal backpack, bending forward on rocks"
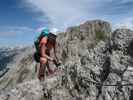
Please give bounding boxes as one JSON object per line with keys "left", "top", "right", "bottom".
{"left": 34, "top": 28, "right": 60, "bottom": 81}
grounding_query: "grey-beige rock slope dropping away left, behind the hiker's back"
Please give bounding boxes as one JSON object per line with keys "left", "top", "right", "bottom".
{"left": 0, "top": 48, "right": 35, "bottom": 92}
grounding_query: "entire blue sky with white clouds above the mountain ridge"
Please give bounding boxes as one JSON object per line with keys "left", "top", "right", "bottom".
{"left": 0, "top": 0, "right": 133, "bottom": 46}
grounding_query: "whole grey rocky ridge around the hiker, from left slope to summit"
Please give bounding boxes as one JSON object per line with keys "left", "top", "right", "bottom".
{"left": 0, "top": 20, "right": 133, "bottom": 100}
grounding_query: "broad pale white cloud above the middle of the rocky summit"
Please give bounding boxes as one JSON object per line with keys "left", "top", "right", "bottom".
{"left": 25, "top": 0, "right": 98, "bottom": 29}
